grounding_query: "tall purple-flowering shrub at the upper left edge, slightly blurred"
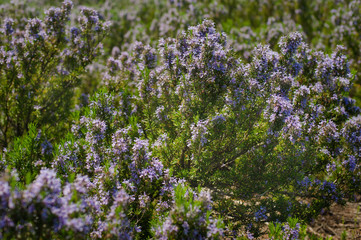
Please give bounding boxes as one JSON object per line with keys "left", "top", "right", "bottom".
{"left": 0, "top": 1, "right": 109, "bottom": 148}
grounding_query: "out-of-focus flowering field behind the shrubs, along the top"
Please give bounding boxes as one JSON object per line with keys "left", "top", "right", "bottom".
{"left": 0, "top": 0, "right": 361, "bottom": 103}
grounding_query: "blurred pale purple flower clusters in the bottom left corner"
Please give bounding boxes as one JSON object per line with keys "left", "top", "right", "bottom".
{"left": 0, "top": 169, "right": 92, "bottom": 238}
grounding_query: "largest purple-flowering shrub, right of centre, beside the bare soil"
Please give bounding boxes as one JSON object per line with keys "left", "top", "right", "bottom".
{"left": 104, "top": 21, "right": 359, "bottom": 234}
